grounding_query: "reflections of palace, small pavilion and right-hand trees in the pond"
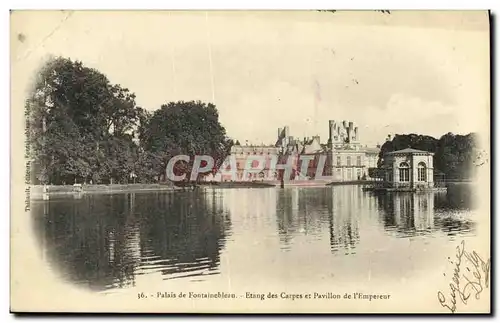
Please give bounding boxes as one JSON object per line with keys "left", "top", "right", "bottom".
{"left": 276, "top": 186, "right": 474, "bottom": 255}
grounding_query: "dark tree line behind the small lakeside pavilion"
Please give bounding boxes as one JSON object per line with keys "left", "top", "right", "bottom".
{"left": 370, "top": 133, "right": 479, "bottom": 180}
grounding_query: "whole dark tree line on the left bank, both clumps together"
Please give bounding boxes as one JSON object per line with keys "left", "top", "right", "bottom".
{"left": 25, "top": 57, "right": 233, "bottom": 185}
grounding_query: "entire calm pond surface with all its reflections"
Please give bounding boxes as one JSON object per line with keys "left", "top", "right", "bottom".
{"left": 32, "top": 184, "right": 475, "bottom": 292}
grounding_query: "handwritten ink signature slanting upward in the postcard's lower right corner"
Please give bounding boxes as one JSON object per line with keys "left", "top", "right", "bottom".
{"left": 437, "top": 240, "right": 491, "bottom": 313}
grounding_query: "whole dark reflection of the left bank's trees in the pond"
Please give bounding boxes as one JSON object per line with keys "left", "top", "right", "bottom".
{"left": 32, "top": 192, "right": 231, "bottom": 290}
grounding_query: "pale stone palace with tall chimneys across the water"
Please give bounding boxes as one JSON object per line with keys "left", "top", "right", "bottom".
{"left": 214, "top": 120, "right": 380, "bottom": 181}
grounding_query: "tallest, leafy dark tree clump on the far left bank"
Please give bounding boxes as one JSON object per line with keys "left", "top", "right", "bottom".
{"left": 26, "top": 57, "right": 141, "bottom": 184}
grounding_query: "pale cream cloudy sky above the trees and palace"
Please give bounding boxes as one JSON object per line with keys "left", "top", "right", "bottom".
{"left": 11, "top": 11, "right": 490, "bottom": 145}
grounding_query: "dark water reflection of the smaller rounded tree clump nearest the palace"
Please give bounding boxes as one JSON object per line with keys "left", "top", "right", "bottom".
{"left": 140, "top": 193, "right": 231, "bottom": 279}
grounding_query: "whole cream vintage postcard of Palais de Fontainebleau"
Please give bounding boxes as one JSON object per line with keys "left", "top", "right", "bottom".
{"left": 10, "top": 10, "right": 491, "bottom": 314}
